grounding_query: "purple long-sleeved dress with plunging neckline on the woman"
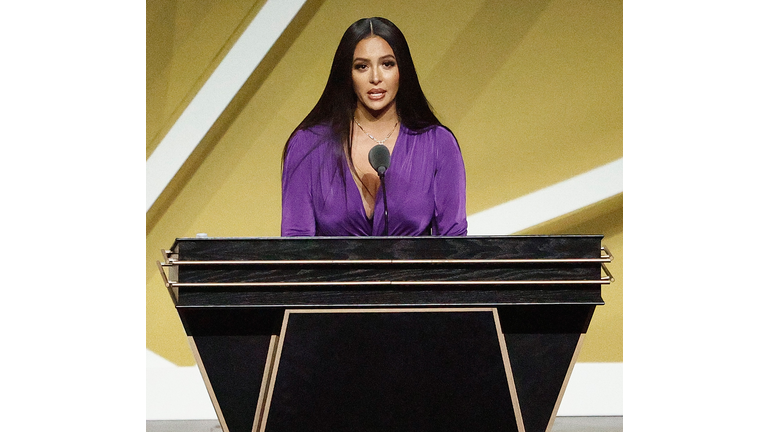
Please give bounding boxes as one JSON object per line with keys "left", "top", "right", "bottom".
{"left": 281, "top": 125, "right": 467, "bottom": 236}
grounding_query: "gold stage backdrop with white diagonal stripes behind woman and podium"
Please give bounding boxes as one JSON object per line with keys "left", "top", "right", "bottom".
{"left": 146, "top": 0, "right": 623, "bottom": 418}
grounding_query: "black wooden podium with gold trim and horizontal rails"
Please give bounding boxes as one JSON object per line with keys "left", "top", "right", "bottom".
{"left": 158, "top": 235, "right": 612, "bottom": 432}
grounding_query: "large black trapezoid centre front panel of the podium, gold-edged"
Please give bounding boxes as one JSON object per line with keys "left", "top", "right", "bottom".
{"left": 265, "top": 310, "right": 518, "bottom": 432}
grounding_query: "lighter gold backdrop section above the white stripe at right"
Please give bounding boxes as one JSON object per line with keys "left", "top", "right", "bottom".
{"left": 452, "top": 2, "right": 622, "bottom": 213}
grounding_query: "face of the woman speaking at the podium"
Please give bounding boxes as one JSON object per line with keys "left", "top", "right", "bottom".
{"left": 352, "top": 36, "right": 400, "bottom": 116}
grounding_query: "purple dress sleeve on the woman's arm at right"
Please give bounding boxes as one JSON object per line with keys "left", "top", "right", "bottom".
{"left": 432, "top": 128, "right": 467, "bottom": 236}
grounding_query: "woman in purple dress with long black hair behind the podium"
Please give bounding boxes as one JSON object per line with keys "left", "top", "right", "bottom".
{"left": 281, "top": 18, "right": 467, "bottom": 236}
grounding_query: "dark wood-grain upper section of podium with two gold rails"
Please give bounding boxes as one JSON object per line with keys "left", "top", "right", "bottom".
{"left": 162, "top": 235, "right": 610, "bottom": 308}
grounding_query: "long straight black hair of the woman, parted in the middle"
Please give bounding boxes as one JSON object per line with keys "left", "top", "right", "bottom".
{"left": 283, "top": 17, "right": 442, "bottom": 169}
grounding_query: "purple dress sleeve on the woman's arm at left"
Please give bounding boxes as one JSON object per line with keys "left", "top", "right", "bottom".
{"left": 280, "top": 131, "right": 315, "bottom": 237}
